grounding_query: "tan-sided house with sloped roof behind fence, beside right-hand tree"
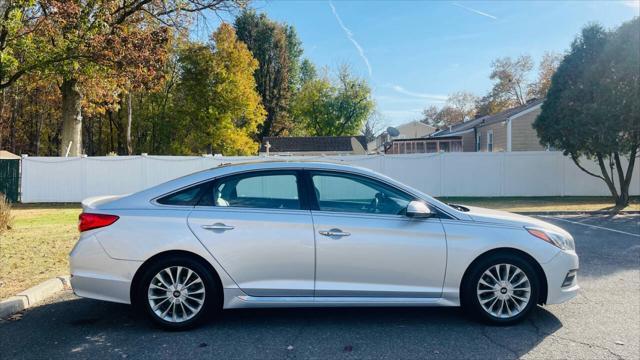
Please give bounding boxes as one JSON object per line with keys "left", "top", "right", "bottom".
{"left": 430, "top": 99, "right": 547, "bottom": 152}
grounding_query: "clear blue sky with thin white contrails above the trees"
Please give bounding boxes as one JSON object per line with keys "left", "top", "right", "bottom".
{"left": 194, "top": 0, "right": 640, "bottom": 125}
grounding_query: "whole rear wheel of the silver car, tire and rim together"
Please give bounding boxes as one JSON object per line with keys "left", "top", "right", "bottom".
{"left": 134, "top": 255, "right": 222, "bottom": 330}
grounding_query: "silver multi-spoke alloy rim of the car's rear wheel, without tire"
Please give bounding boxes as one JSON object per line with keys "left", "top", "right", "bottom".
{"left": 147, "top": 266, "right": 206, "bottom": 323}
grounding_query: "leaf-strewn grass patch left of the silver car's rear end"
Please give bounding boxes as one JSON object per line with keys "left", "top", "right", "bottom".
{"left": 0, "top": 204, "right": 80, "bottom": 299}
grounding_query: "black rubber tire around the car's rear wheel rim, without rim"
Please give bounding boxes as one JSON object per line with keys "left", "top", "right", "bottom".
{"left": 134, "top": 255, "right": 222, "bottom": 330}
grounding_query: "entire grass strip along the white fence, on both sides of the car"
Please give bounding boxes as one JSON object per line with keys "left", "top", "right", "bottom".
{"left": 0, "top": 197, "right": 640, "bottom": 299}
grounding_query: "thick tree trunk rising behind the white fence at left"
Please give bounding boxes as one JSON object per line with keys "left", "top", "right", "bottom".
{"left": 60, "top": 79, "right": 82, "bottom": 156}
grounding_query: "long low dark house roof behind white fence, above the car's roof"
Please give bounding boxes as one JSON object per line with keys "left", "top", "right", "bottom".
{"left": 260, "top": 136, "right": 367, "bottom": 153}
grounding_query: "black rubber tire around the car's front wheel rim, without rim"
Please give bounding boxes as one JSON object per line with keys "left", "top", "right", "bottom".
{"left": 460, "top": 253, "right": 540, "bottom": 325}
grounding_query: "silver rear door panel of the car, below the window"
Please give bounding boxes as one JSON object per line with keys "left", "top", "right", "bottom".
{"left": 189, "top": 207, "right": 315, "bottom": 296}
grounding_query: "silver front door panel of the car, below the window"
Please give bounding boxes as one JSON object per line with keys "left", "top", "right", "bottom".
{"left": 313, "top": 211, "right": 447, "bottom": 297}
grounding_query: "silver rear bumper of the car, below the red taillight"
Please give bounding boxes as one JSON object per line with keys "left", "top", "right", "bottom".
{"left": 69, "top": 235, "right": 142, "bottom": 304}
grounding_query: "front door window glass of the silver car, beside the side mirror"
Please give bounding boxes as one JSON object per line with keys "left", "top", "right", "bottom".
{"left": 312, "top": 173, "right": 412, "bottom": 215}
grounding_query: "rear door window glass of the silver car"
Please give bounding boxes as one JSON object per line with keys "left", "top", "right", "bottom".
{"left": 207, "top": 172, "right": 300, "bottom": 209}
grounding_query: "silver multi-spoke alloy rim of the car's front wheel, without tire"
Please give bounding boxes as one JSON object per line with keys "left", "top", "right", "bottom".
{"left": 476, "top": 264, "right": 531, "bottom": 319}
